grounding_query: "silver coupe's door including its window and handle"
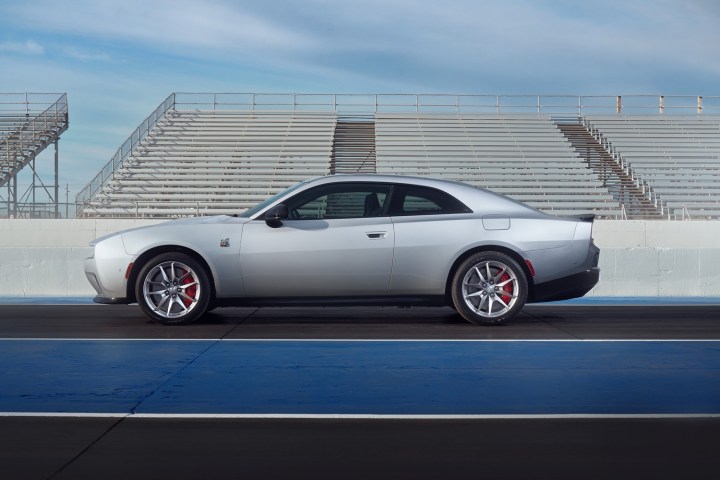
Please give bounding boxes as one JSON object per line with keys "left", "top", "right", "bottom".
{"left": 240, "top": 183, "right": 395, "bottom": 298}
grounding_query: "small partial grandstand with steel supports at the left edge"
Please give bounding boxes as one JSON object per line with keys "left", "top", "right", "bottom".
{"left": 0, "top": 93, "right": 68, "bottom": 218}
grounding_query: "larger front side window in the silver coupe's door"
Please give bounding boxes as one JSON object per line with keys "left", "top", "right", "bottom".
{"left": 286, "top": 183, "right": 390, "bottom": 220}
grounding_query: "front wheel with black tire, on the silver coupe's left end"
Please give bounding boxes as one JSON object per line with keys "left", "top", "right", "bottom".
{"left": 135, "top": 252, "right": 212, "bottom": 325}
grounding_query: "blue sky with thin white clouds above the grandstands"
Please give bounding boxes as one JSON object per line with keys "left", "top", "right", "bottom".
{"left": 0, "top": 0, "right": 720, "bottom": 201}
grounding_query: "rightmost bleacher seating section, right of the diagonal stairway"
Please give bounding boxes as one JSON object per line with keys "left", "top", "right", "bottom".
{"left": 585, "top": 115, "right": 720, "bottom": 218}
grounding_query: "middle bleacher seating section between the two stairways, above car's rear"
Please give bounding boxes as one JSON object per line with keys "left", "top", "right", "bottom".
{"left": 375, "top": 113, "right": 621, "bottom": 218}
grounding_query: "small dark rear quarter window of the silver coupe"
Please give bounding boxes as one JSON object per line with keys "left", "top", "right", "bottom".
{"left": 390, "top": 185, "right": 471, "bottom": 216}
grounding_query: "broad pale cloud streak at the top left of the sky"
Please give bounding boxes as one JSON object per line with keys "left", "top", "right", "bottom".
{"left": 6, "top": 0, "right": 312, "bottom": 55}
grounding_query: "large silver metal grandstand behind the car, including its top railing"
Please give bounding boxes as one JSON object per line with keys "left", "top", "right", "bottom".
{"left": 77, "top": 94, "right": 720, "bottom": 218}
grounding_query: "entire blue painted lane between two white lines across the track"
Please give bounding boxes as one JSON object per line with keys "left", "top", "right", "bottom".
{"left": 0, "top": 341, "right": 720, "bottom": 415}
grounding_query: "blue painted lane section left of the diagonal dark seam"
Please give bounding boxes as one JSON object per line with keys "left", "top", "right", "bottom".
{"left": 0, "top": 340, "right": 215, "bottom": 413}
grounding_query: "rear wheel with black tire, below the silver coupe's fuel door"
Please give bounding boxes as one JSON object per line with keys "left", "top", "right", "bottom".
{"left": 451, "top": 252, "right": 528, "bottom": 325}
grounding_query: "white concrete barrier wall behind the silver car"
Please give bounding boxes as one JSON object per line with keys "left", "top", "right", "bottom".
{"left": 0, "top": 219, "right": 720, "bottom": 297}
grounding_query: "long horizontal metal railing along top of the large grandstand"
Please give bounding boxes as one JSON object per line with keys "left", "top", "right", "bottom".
{"left": 175, "top": 92, "right": 720, "bottom": 116}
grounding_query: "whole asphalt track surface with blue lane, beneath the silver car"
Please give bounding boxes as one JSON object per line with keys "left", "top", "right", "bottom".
{"left": 0, "top": 304, "right": 720, "bottom": 479}
